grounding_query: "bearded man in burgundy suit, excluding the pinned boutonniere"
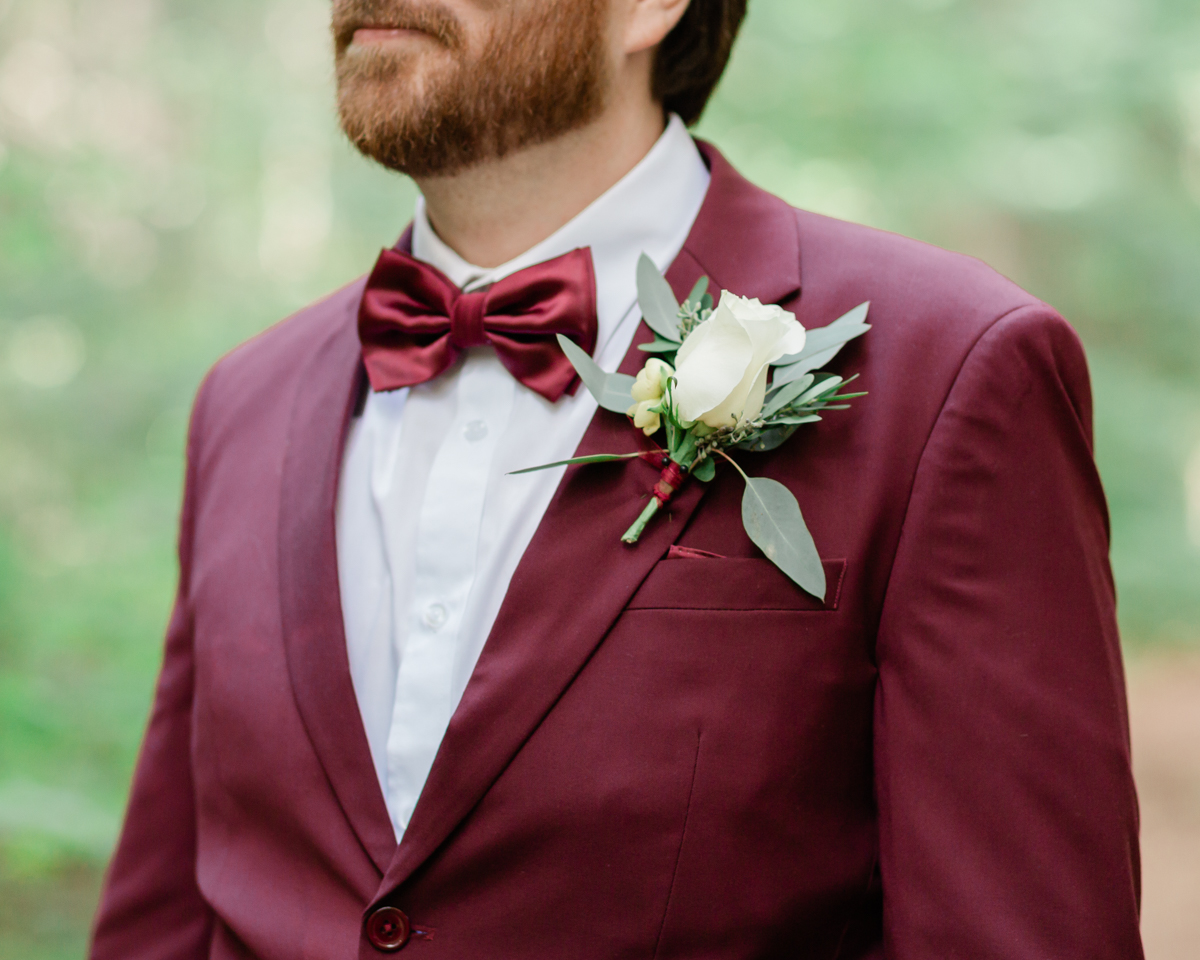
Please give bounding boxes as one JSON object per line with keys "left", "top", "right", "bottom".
{"left": 91, "top": 0, "right": 1141, "bottom": 960}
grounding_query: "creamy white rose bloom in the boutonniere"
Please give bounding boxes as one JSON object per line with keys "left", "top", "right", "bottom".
{"left": 672, "top": 290, "right": 804, "bottom": 427}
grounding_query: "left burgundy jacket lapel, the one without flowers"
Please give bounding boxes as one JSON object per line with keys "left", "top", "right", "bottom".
{"left": 278, "top": 280, "right": 396, "bottom": 874}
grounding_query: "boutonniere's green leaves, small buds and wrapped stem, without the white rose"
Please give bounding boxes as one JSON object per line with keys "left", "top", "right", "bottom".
{"left": 516, "top": 254, "right": 870, "bottom": 599}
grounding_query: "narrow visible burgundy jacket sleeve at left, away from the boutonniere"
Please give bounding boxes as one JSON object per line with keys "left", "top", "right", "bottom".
{"left": 89, "top": 379, "right": 212, "bottom": 960}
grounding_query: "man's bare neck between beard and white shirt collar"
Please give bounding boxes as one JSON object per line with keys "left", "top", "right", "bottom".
{"left": 418, "top": 88, "right": 664, "bottom": 268}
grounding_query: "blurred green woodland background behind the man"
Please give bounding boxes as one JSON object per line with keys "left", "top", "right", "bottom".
{"left": 0, "top": 0, "right": 1200, "bottom": 960}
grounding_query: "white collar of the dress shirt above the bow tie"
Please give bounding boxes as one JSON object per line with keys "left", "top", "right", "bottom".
{"left": 413, "top": 114, "right": 710, "bottom": 355}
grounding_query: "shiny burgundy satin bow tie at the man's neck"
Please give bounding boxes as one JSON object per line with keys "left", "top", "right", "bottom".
{"left": 359, "top": 248, "right": 596, "bottom": 403}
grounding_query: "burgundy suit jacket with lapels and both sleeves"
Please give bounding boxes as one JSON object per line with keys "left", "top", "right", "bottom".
{"left": 91, "top": 146, "right": 1141, "bottom": 960}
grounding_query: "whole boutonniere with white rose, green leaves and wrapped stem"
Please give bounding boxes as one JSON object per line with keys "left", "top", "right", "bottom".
{"left": 517, "top": 254, "right": 870, "bottom": 600}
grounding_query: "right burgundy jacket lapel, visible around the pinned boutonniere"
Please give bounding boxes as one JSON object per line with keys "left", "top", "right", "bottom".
{"left": 380, "top": 144, "right": 799, "bottom": 896}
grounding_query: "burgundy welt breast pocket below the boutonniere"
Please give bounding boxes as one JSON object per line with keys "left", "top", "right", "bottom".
{"left": 625, "top": 557, "right": 846, "bottom": 611}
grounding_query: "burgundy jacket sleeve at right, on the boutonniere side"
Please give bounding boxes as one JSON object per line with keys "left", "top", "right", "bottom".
{"left": 875, "top": 305, "right": 1142, "bottom": 960}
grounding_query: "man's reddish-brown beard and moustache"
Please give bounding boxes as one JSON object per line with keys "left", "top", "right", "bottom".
{"left": 332, "top": 0, "right": 610, "bottom": 178}
